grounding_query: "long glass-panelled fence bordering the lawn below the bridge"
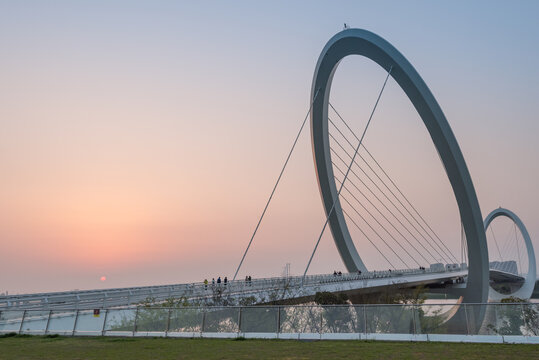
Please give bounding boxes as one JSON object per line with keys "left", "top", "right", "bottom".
{"left": 0, "top": 303, "right": 539, "bottom": 342}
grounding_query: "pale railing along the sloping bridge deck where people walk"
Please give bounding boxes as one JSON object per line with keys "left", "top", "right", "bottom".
{"left": 0, "top": 269, "right": 459, "bottom": 310}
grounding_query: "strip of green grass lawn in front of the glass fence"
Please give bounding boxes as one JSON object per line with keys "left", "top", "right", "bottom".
{"left": 0, "top": 336, "right": 539, "bottom": 360}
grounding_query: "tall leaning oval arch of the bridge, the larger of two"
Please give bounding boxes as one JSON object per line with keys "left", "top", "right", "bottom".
{"left": 311, "top": 29, "right": 489, "bottom": 306}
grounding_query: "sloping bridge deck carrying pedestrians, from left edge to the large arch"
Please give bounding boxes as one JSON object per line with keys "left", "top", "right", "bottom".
{"left": 0, "top": 266, "right": 467, "bottom": 311}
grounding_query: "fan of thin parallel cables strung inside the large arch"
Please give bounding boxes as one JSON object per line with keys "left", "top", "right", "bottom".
{"left": 328, "top": 103, "right": 459, "bottom": 268}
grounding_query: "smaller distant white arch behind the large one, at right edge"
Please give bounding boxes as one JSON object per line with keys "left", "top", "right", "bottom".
{"left": 484, "top": 207, "right": 537, "bottom": 301}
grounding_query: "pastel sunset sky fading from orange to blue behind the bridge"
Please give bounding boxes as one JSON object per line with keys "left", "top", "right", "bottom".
{"left": 0, "top": 0, "right": 539, "bottom": 294}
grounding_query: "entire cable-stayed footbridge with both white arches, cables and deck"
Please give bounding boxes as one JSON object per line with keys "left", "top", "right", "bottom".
{"left": 0, "top": 29, "right": 536, "bottom": 338}
